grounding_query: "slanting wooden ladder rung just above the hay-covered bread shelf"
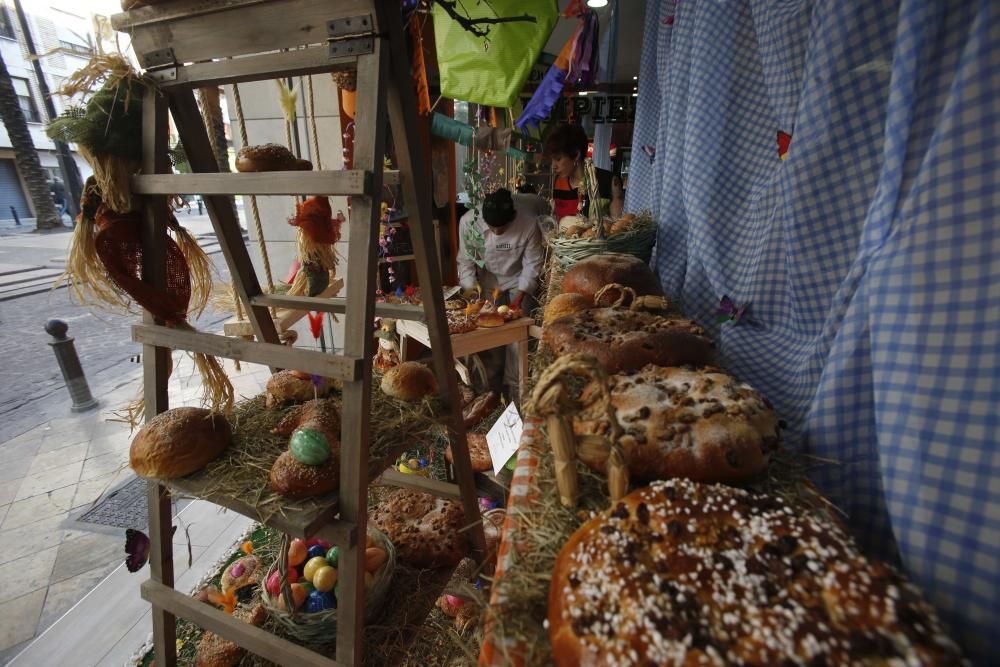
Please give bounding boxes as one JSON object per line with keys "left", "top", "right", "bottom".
{"left": 132, "top": 324, "right": 362, "bottom": 382}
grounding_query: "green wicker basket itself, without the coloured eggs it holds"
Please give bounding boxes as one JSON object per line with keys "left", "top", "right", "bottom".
{"left": 260, "top": 525, "right": 396, "bottom": 645}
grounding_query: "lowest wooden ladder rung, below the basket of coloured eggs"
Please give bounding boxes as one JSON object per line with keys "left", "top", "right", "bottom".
{"left": 140, "top": 579, "right": 340, "bottom": 667}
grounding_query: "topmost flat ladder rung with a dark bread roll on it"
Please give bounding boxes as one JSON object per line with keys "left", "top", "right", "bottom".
{"left": 132, "top": 169, "right": 371, "bottom": 195}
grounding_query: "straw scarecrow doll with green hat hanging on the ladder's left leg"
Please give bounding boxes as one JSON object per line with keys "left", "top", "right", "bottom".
{"left": 47, "top": 53, "right": 234, "bottom": 421}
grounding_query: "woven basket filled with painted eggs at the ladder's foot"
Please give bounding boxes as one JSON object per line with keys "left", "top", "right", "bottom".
{"left": 261, "top": 525, "right": 396, "bottom": 645}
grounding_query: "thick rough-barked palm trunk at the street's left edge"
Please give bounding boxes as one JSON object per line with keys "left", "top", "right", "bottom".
{"left": 0, "top": 51, "right": 62, "bottom": 229}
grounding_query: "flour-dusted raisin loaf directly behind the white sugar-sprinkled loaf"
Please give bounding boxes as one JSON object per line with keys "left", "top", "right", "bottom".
{"left": 573, "top": 366, "right": 778, "bottom": 483}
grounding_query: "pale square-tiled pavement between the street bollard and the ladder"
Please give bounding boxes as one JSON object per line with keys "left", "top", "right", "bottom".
{"left": 0, "top": 353, "right": 269, "bottom": 665}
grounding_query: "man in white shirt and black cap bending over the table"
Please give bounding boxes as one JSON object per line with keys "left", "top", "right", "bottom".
{"left": 458, "top": 188, "right": 547, "bottom": 400}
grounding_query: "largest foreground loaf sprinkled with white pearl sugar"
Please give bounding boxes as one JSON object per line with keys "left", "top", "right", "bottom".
{"left": 548, "top": 480, "right": 961, "bottom": 666}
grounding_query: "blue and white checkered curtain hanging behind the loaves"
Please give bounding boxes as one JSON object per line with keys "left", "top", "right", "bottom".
{"left": 626, "top": 0, "right": 1000, "bottom": 663}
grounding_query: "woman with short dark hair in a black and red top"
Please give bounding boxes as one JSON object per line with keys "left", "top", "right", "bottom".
{"left": 545, "top": 125, "right": 625, "bottom": 220}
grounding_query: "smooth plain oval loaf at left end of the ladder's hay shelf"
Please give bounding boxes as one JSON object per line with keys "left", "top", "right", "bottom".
{"left": 129, "top": 408, "right": 233, "bottom": 479}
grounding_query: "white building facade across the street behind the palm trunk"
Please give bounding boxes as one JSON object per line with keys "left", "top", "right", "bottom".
{"left": 0, "top": 0, "right": 94, "bottom": 219}
